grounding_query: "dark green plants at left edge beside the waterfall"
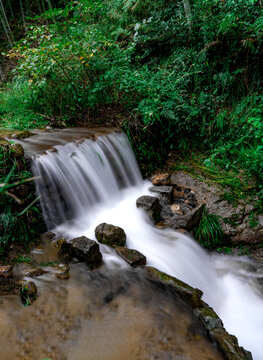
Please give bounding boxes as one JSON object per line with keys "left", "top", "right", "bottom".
{"left": 0, "top": 145, "right": 41, "bottom": 257}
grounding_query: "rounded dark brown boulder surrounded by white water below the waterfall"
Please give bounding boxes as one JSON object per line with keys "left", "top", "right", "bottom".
{"left": 95, "top": 223, "right": 126, "bottom": 246}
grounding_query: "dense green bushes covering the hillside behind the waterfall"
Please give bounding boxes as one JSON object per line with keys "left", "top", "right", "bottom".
{"left": 0, "top": 0, "right": 263, "bottom": 181}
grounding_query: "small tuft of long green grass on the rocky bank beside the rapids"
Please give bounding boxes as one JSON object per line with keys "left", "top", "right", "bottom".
{"left": 194, "top": 210, "right": 224, "bottom": 250}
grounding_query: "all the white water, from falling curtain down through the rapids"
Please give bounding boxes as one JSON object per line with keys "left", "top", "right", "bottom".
{"left": 33, "top": 134, "right": 263, "bottom": 360}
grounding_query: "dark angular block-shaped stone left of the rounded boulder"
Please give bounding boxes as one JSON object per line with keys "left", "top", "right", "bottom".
{"left": 69, "top": 236, "right": 102, "bottom": 268}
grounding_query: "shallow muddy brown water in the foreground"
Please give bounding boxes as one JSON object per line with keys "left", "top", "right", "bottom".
{"left": 0, "top": 264, "right": 222, "bottom": 360}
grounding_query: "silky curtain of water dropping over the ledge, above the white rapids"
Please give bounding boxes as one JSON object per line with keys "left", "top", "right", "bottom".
{"left": 32, "top": 133, "right": 142, "bottom": 228}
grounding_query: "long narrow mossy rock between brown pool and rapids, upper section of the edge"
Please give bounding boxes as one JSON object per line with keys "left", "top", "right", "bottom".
{"left": 145, "top": 267, "right": 203, "bottom": 308}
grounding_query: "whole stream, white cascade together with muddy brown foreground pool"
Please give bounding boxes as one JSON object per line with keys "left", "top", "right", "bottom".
{"left": 0, "top": 134, "right": 263, "bottom": 360}
